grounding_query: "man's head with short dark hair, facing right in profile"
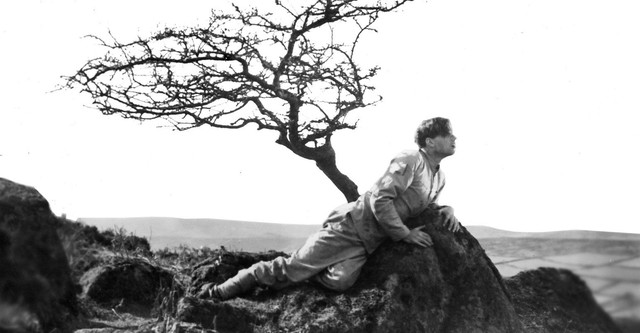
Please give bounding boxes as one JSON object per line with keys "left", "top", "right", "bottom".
{"left": 415, "top": 117, "right": 456, "bottom": 157}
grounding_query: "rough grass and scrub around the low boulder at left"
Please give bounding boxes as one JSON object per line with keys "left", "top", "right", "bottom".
{"left": 55, "top": 219, "right": 232, "bottom": 331}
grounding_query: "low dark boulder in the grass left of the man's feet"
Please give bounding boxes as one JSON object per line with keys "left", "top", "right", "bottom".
{"left": 80, "top": 258, "right": 183, "bottom": 316}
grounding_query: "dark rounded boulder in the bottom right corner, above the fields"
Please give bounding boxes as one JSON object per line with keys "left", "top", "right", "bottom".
{"left": 505, "top": 267, "right": 621, "bottom": 333}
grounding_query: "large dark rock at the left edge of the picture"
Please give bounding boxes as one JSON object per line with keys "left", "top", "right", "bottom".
{"left": 0, "top": 178, "right": 77, "bottom": 332}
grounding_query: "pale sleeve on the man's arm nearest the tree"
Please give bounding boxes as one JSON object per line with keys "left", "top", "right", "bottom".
{"left": 369, "top": 155, "right": 416, "bottom": 241}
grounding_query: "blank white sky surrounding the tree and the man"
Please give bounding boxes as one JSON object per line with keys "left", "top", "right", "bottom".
{"left": 0, "top": 0, "right": 640, "bottom": 233}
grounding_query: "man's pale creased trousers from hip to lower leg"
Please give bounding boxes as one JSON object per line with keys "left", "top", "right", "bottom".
{"left": 246, "top": 210, "right": 367, "bottom": 291}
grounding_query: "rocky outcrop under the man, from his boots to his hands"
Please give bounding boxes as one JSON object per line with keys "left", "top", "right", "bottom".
{"left": 178, "top": 213, "right": 523, "bottom": 333}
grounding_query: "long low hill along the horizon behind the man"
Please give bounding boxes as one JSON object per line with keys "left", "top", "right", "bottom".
{"left": 79, "top": 217, "right": 640, "bottom": 252}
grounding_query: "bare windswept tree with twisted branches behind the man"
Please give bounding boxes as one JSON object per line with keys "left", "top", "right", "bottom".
{"left": 67, "top": 0, "right": 411, "bottom": 201}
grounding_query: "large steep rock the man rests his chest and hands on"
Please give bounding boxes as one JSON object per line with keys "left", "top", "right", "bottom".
{"left": 352, "top": 213, "right": 522, "bottom": 332}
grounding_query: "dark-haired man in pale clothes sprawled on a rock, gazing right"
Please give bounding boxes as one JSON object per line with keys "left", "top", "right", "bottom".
{"left": 198, "top": 118, "right": 460, "bottom": 300}
